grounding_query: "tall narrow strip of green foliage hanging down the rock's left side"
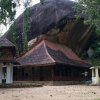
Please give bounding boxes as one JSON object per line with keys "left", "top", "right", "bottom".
{"left": 22, "top": 0, "right": 31, "bottom": 52}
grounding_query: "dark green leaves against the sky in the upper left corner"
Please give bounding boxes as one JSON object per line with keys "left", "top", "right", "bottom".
{"left": 0, "top": 0, "right": 16, "bottom": 25}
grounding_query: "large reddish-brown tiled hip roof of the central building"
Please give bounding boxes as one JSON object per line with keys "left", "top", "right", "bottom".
{"left": 17, "top": 40, "right": 90, "bottom": 67}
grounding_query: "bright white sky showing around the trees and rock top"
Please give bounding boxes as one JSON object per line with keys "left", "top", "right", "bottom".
{"left": 0, "top": 0, "right": 75, "bottom": 35}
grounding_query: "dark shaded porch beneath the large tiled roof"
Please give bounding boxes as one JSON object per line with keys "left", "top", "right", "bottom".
{"left": 13, "top": 64, "right": 91, "bottom": 81}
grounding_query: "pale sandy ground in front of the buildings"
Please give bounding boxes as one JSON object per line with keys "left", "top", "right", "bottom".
{"left": 0, "top": 85, "right": 100, "bottom": 100}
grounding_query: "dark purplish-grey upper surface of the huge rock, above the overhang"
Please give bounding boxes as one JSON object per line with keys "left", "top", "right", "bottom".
{"left": 5, "top": 0, "right": 75, "bottom": 40}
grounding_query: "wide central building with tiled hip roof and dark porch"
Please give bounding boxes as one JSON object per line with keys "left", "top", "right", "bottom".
{"left": 14, "top": 40, "right": 91, "bottom": 81}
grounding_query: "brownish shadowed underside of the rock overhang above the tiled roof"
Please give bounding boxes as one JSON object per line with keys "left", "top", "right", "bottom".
{"left": 28, "top": 19, "right": 93, "bottom": 54}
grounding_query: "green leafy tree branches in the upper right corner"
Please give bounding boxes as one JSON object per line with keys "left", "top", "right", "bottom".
{"left": 75, "top": 0, "right": 100, "bottom": 34}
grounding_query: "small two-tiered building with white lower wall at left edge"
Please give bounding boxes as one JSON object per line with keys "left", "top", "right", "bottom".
{"left": 0, "top": 38, "right": 16, "bottom": 84}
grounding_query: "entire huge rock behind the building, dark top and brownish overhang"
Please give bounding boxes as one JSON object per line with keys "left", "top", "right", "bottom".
{"left": 3, "top": 0, "right": 92, "bottom": 54}
